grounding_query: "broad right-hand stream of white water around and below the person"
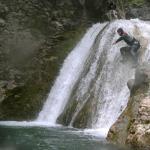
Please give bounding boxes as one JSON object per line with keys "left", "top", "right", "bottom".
{"left": 87, "top": 20, "right": 150, "bottom": 136}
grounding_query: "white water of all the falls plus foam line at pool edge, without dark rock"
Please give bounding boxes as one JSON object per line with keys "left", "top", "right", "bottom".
{"left": 0, "top": 20, "right": 150, "bottom": 136}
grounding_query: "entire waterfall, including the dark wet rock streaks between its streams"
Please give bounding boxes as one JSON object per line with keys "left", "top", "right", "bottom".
{"left": 0, "top": 19, "right": 150, "bottom": 136}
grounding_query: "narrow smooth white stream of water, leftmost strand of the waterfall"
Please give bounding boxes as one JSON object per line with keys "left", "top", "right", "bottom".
{"left": 37, "top": 23, "right": 106, "bottom": 124}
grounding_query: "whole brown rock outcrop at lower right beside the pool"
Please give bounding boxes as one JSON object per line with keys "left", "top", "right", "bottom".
{"left": 107, "top": 65, "right": 150, "bottom": 150}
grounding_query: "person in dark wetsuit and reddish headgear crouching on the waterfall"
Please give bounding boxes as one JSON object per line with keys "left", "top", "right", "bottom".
{"left": 113, "top": 28, "right": 140, "bottom": 64}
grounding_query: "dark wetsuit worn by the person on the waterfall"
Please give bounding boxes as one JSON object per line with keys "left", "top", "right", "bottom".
{"left": 116, "top": 33, "right": 140, "bottom": 62}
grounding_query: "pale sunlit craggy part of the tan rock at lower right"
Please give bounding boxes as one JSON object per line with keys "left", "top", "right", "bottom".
{"left": 127, "top": 96, "right": 150, "bottom": 149}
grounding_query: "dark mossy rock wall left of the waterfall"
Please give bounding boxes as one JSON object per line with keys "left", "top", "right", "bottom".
{"left": 0, "top": 0, "right": 111, "bottom": 120}
